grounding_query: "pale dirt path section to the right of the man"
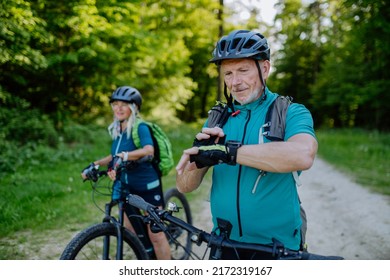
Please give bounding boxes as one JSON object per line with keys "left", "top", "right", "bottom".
{"left": 299, "top": 159, "right": 390, "bottom": 260}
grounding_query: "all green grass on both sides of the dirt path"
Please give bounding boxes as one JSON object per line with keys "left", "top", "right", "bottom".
{"left": 0, "top": 124, "right": 390, "bottom": 259}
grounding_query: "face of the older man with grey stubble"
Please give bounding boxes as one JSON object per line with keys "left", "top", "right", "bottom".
{"left": 221, "top": 59, "right": 267, "bottom": 105}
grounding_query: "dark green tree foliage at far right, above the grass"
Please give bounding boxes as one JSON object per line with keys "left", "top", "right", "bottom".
{"left": 311, "top": 1, "right": 390, "bottom": 130}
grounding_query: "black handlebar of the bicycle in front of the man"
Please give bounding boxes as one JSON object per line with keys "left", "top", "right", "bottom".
{"left": 127, "top": 194, "right": 343, "bottom": 260}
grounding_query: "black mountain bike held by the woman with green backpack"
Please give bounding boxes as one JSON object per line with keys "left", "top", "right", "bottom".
{"left": 60, "top": 160, "right": 192, "bottom": 260}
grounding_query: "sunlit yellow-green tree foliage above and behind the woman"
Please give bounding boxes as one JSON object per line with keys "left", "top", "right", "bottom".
{"left": 0, "top": 0, "right": 219, "bottom": 126}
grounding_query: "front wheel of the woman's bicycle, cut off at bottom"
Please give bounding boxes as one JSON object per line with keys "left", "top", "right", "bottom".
{"left": 60, "top": 222, "right": 149, "bottom": 260}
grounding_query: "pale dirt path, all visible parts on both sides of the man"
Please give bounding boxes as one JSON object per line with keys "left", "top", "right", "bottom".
{"left": 0, "top": 156, "right": 390, "bottom": 260}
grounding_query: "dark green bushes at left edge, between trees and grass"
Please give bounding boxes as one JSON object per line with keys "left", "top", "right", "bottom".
{"left": 0, "top": 88, "right": 109, "bottom": 175}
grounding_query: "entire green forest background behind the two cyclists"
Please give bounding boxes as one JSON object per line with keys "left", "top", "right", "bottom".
{"left": 0, "top": 0, "right": 390, "bottom": 258}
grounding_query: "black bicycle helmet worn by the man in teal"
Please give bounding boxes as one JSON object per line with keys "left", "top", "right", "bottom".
{"left": 210, "top": 30, "right": 270, "bottom": 64}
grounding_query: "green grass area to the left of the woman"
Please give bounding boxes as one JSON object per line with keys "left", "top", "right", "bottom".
{"left": 0, "top": 121, "right": 111, "bottom": 236}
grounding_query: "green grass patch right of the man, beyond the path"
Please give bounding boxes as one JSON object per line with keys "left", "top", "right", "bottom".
{"left": 317, "top": 129, "right": 390, "bottom": 195}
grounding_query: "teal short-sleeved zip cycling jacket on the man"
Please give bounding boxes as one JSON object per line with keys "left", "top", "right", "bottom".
{"left": 205, "top": 89, "right": 315, "bottom": 250}
